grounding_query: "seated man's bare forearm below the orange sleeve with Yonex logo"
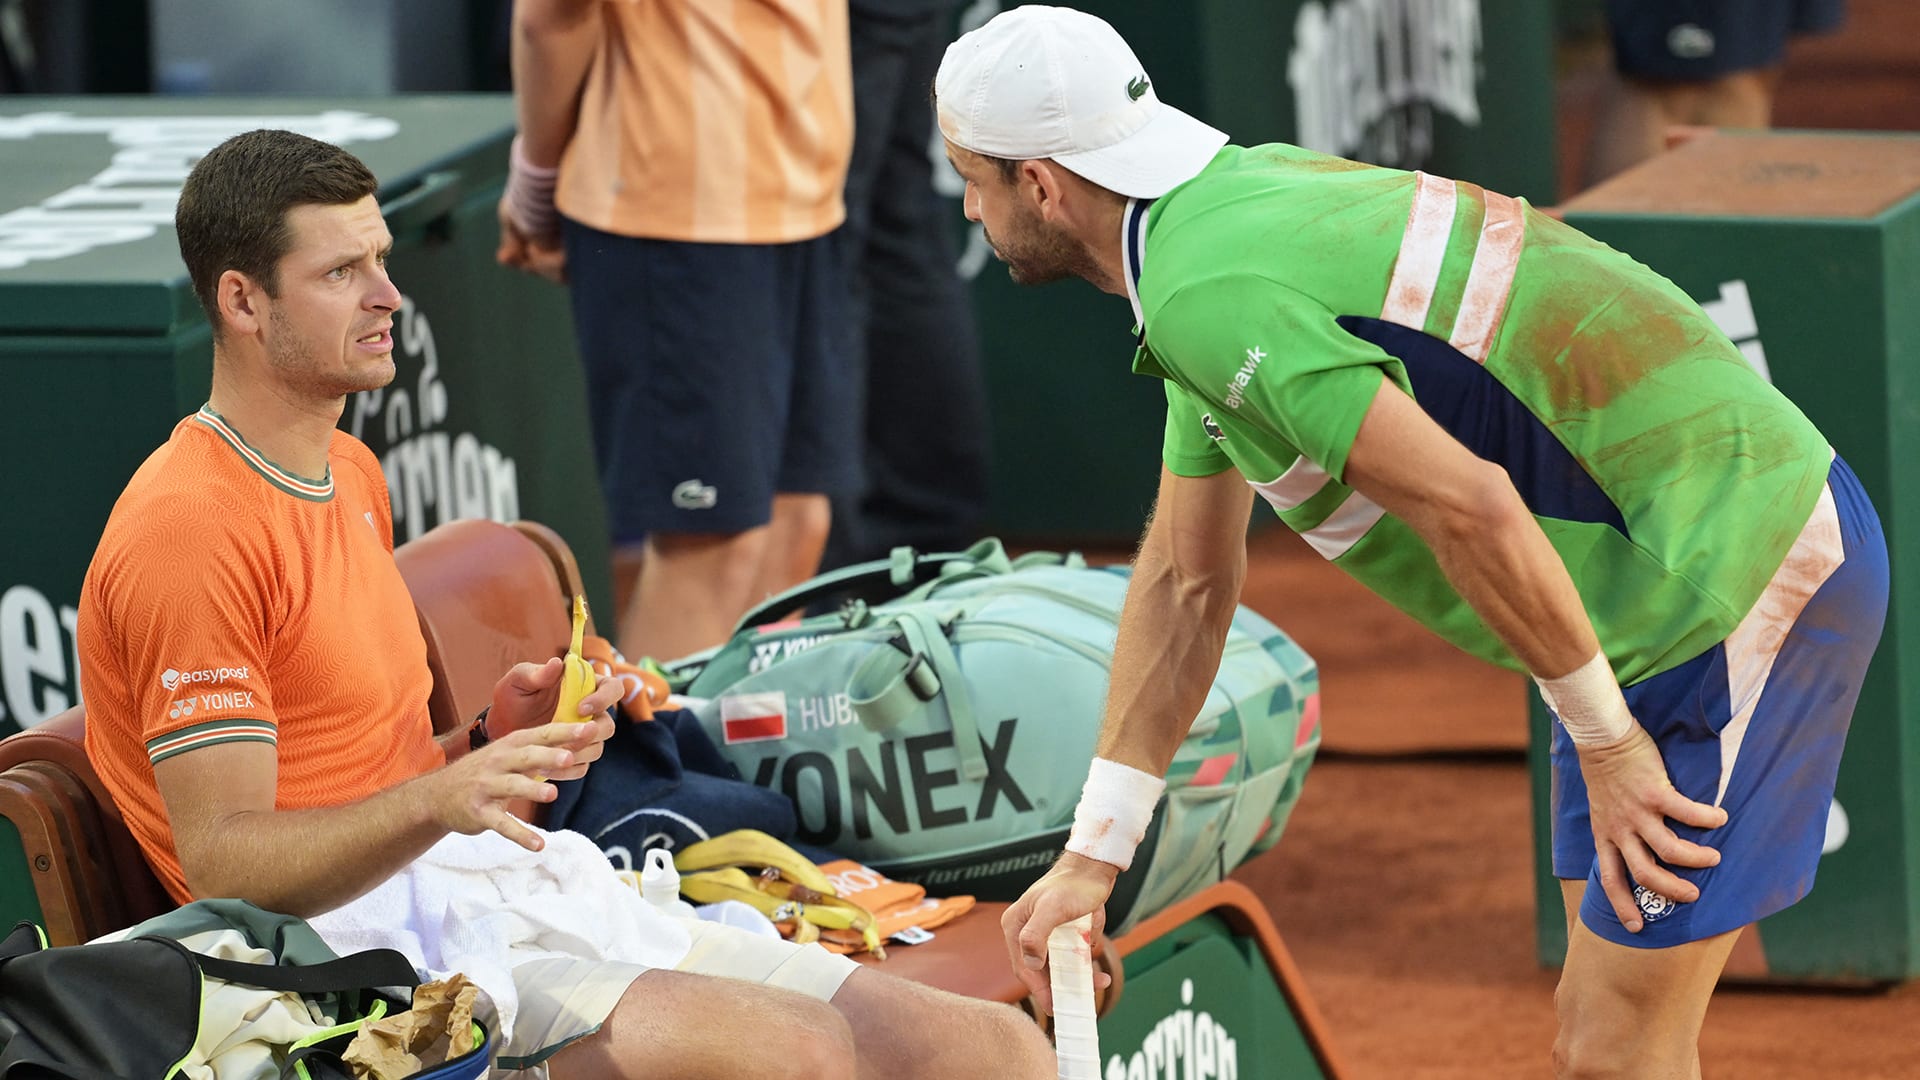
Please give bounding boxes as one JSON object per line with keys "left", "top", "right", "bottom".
{"left": 179, "top": 773, "right": 447, "bottom": 919}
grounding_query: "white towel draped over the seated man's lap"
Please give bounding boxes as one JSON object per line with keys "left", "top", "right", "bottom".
{"left": 307, "top": 830, "right": 691, "bottom": 1045}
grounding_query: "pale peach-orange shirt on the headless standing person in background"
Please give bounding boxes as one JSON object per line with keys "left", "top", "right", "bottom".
{"left": 555, "top": 0, "right": 852, "bottom": 244}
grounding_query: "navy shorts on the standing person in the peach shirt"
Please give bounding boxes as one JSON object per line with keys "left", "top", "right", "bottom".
{"left": 564, "top": 221, "right": 862, "bottom": 544}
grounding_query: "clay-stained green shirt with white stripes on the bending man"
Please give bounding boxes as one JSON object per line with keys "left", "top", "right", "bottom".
{"left": 1123, "top": 144, "right": 1832, "bottom": 684}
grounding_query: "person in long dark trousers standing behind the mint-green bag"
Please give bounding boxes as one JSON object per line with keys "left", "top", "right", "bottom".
{"left": 824, "top": 0, "right": 989, "bottom": 567}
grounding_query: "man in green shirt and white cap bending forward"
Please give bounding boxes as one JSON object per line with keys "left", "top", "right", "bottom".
{"left": 935, "top": 6, "right": 1887, "bottom": 1076}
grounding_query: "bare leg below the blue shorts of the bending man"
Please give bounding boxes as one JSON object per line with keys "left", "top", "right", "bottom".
{"left": 1553, "top": 880, "right": 1740, "bottom": 1080}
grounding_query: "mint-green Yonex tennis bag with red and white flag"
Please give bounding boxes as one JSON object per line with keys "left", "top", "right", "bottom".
{"left": 670, "top": 540, "right": 1319, "bottom": 932}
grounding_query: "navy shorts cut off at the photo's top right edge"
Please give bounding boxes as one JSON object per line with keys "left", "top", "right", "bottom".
{"left": 1607, "top": 0, "right": 1847, "bottom": 83}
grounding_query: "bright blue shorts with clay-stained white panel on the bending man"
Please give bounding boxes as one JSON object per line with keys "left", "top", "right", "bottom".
{"left": 1553, "top": 457, "right": 1887, "bottom": 949}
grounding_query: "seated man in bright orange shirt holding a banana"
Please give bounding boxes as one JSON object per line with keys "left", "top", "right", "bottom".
{"left": 79, "top": 131, "right": 1052, "bottom": 1080}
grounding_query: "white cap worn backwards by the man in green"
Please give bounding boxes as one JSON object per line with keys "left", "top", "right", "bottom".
{"left": 933, "top": 4, "right": 1227, "bottom": 198}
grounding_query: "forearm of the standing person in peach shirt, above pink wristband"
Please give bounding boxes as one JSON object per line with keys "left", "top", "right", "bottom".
{"left": 513, "top": 0, "right": 601, "bottom": 167}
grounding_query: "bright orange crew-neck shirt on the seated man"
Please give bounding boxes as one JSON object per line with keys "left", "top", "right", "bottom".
{"left": 77, "top": 407, "right": 444, "bottom": 901}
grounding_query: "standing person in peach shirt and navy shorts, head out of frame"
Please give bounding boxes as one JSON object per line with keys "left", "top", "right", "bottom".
{"left": 499, "top": 0, "right": 860, "bottom": 659}
